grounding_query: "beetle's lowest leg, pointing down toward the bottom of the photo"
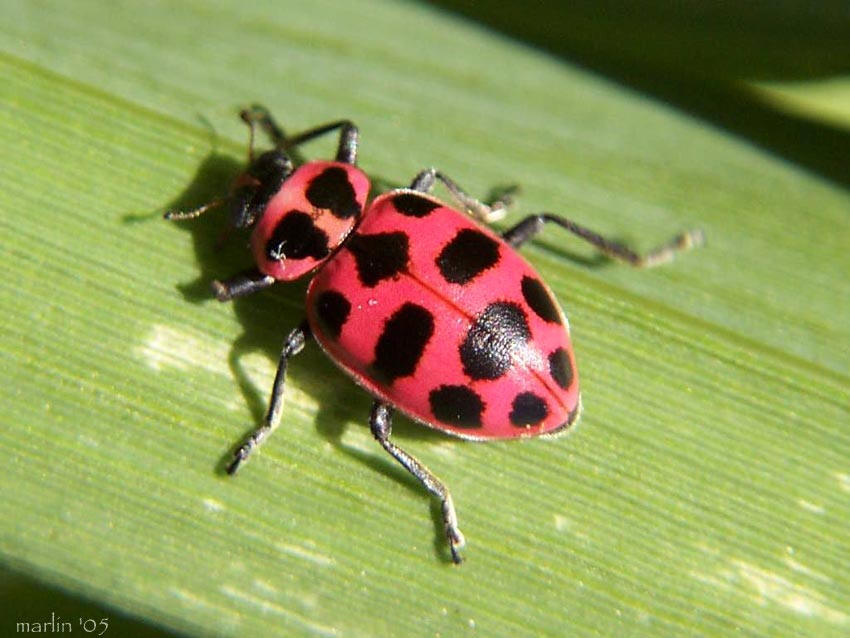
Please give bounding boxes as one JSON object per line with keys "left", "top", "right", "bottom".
{"left": 369, "top": 401, "right": 466, "bottom": 563}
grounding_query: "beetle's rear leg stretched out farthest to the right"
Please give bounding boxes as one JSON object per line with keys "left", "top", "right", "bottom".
{"left": 502, "top": 213, "right": 705, "bottom": 268}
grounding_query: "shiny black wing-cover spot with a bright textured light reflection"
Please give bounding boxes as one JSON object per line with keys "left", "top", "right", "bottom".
{"left": 460, "top": 301, "right": 531, "bottom": 379}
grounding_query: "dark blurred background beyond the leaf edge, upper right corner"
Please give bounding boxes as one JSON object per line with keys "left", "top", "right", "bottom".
{"left": 437, "top": 0, "right": 850, "bottom": 186}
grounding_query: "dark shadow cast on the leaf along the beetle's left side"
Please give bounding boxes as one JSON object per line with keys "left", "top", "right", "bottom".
{"left": 163, "top": 152, "right": 454, "bottom": 464}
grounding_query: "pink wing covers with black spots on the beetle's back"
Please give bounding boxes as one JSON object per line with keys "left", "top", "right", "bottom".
{"left": 307, "top": 190, "right": 579, "bottom": 440}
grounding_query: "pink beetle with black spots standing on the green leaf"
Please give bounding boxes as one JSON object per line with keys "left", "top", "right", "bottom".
{"left": 165, "top": 105, "right": 703, "bottom": 563}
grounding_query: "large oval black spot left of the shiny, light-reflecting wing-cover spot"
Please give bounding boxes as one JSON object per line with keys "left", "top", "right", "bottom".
{"left": 372, "top": 302, "right": 434, "bottom": 383}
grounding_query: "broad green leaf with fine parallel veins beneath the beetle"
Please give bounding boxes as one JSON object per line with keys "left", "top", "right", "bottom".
{"left": 0, "top": 0, "right": 850, "bottom": 636}
